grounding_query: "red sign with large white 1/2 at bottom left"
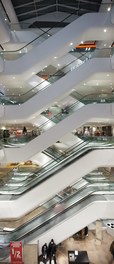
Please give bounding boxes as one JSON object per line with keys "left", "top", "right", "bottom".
{"left": 10, "top": 241, "right": 23, "bottom": 264}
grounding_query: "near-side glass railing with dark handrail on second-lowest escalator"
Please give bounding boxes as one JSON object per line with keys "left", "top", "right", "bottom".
{"left": 0, "top": 136, "right": 113, "bottom": 198}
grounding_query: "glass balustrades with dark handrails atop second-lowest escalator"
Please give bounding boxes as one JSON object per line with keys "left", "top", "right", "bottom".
{"left": 0, "top": 137, "right": 114, "bottom": 199}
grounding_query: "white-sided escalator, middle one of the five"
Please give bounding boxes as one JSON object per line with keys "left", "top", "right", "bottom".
{"left": 2, "top": 102, "right": 112, "bottom": 162}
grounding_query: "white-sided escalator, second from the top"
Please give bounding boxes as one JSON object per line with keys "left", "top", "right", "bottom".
{"left": 1, "top": 54, "right": 113, "bottom": 122}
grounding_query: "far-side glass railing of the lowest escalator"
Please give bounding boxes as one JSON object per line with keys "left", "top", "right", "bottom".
{"left": 0, "top": 184, "right": 114, "bottom": 243}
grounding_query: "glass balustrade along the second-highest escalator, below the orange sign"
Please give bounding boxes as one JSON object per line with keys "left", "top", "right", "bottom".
{"left": 0, "top": 47, "right": 114, "bottom": 105}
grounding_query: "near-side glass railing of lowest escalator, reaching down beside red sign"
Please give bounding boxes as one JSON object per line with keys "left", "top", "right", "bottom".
{"left": 0, "top": 192, "right": 113, "bottom": 259}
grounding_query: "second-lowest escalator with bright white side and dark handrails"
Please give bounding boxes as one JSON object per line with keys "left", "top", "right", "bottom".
{"left": 0, "top": 137, "right": 114, "bottom": 219}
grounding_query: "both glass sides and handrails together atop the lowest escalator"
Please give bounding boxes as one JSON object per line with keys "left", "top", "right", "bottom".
{"left": 0, "top": 179, "right": 114, "bottom": 256}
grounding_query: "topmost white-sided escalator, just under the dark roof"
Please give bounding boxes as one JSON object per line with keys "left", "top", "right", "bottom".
{"left": 1, "top": 9, "right": 113, "bottom": 75}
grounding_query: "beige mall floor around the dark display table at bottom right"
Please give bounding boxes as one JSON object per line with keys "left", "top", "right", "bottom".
{"left": 52, "top": 230, "right": 114, "bottom": 264}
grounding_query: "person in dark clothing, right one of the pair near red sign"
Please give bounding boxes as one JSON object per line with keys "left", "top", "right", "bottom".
{"left": 48, "top": 239, "right": 57, "bottom": 264}
